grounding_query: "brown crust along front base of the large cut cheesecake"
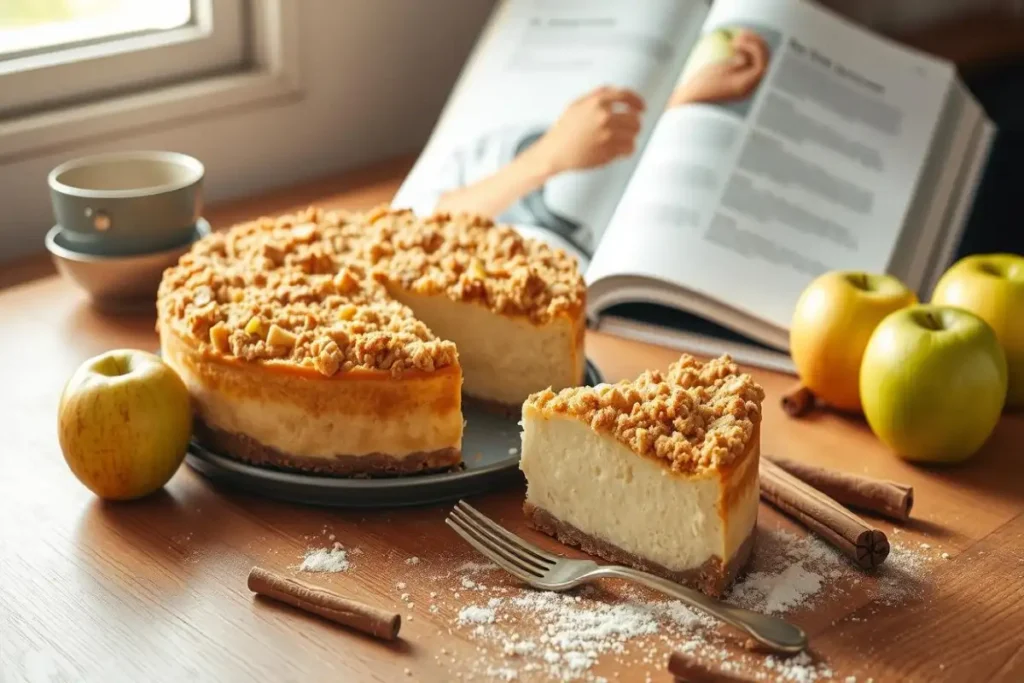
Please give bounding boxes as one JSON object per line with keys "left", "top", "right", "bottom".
{"left": 195, "top": 419, "right": 462, "bottom": 478}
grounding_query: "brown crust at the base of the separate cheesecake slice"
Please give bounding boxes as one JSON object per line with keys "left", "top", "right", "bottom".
{"left": 523, "top": 503, "right": 756, "bottom": 598}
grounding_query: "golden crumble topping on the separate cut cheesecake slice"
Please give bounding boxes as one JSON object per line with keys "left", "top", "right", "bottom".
{"left": 524, "top": 354, "right": 765, "bottom": 473}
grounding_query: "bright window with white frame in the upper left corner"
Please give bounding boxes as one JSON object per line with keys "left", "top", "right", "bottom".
{"left": 0, "top": 0, "right": 301, "bottom": 160}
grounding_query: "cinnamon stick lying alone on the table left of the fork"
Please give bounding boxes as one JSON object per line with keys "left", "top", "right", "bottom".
{"left": 249, "top": 567, "right": 401, "bottom": 640}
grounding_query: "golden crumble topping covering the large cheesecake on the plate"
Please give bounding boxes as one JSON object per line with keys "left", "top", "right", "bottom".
{"left": 158, "top": 208, "right": 585, "bottom": 377}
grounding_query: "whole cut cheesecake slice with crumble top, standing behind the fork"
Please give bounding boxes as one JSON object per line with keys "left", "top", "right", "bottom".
{"left": 520, "top": 355, "right": 764, "bottom": 596}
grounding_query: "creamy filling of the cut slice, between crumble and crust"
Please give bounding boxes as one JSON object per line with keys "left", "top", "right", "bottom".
{"left": 520, "top": 413, "right": 758, "bottom": 572}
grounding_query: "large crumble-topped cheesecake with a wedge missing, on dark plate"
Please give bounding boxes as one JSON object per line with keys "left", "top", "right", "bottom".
{"left": 157, "top": 209, "right": 585, "bottom": 476}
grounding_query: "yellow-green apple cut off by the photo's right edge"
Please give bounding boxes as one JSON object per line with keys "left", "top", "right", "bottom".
{"left": 932, "top": 254, "right": 1024, "bottom": 410}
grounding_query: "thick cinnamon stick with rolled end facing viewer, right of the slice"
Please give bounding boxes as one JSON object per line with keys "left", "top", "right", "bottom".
{"left": 761, "top": 460, "right": 889, "bottom": 569}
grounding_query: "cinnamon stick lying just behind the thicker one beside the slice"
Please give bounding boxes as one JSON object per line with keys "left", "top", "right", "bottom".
{"left": 762, "top": 457, "right": 913, "bottom": 521}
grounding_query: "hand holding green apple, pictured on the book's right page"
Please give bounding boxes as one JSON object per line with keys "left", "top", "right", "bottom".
{"left": 669, "top": 30, "right": 768, "bottom": 109}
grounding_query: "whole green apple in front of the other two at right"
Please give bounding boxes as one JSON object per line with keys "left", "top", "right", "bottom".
{"left": 860, "top": 305, "right": 1007, "bottom": 463}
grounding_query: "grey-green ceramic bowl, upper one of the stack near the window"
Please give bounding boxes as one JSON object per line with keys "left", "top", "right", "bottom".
{"left": 47, "top": 152, "right": 205, "bottom": 256}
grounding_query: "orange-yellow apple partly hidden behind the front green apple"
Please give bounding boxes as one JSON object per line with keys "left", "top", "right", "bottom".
{"left": 790, "top": 270, "right": 918, "bottom": 412}
